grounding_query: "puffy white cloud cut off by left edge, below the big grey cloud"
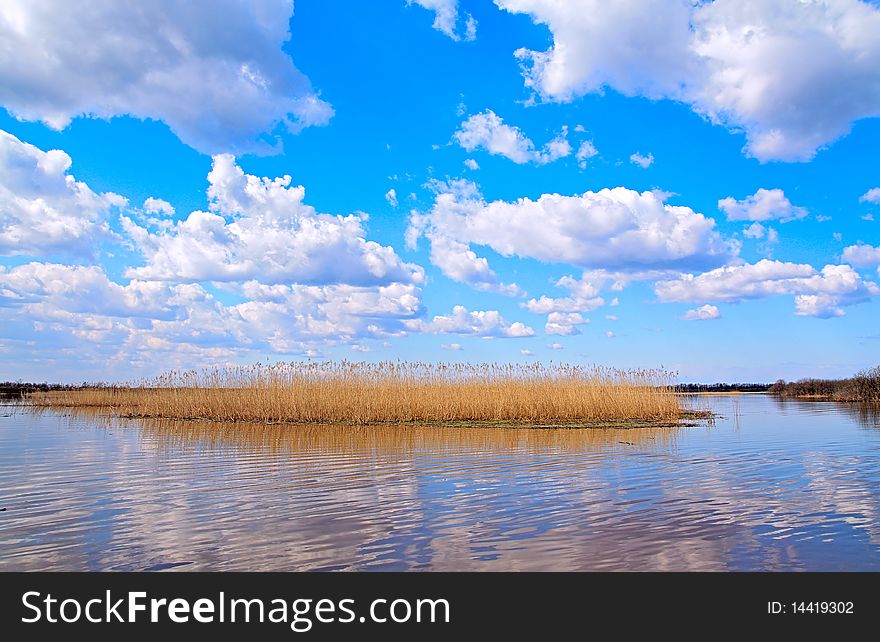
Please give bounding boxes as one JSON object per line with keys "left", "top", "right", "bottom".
{"left": 0, "top": 130, "right": 127, "bottom": 258}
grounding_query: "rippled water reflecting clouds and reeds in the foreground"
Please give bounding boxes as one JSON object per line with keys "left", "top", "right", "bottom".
{"left": 0, "top": 395, "right": 880, "bottom": 571}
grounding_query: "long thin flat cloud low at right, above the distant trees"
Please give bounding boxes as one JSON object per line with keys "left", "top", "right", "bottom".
{"left": 654, "top": 259, "right": 880, "bottom": 318}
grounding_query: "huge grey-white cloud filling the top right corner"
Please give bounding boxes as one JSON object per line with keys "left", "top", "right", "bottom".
{"left": 496, "top": 0, "right": 880, "bottom": 161}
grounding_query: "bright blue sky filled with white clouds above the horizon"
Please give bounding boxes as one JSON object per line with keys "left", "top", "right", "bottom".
{"left": 0, "top": 0, "right": 880, "bottom": 381}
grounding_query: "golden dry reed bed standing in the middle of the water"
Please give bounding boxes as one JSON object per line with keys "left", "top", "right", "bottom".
{"left": 27, "top": 361, "right": 687, "bottom": 426}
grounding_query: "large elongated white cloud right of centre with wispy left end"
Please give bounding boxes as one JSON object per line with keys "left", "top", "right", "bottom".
{"left": 407, "top": 181, "right": 736, "bottom": 296}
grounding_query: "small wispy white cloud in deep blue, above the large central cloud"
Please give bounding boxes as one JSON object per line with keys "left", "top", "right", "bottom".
{"left": 453, "top": 109, "right": 572, "bottom": 165}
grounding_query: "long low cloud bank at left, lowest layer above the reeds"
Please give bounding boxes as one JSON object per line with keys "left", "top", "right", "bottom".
{"left": 0, "top": 263, "right": 422, "bottom": 359}
